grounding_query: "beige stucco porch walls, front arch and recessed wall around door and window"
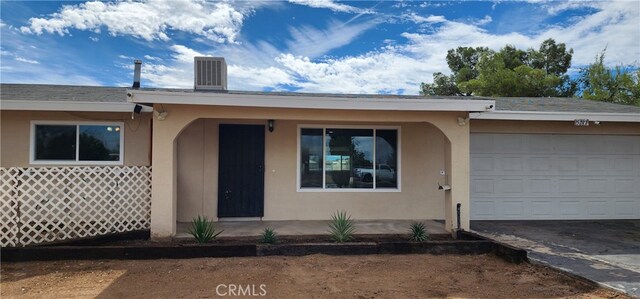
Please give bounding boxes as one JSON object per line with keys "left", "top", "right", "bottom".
{"left": 151, "top": 104, "right": 469, "bottom": 238}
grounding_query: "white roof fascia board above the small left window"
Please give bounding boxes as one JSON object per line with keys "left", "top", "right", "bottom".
{"left": 0, "top": 100, "right": 153, "bottom": 112}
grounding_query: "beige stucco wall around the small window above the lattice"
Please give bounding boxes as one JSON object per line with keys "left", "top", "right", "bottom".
{"left": 0, "top": 110, "right": 151, "bottom": 167}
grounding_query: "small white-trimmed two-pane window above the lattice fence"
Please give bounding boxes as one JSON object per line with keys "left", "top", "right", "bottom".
{"left": 30, "top": 122, "right": 124, "bottom": 165}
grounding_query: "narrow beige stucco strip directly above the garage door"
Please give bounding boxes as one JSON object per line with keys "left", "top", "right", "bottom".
{"left": 471, "top": 119, "right": 640, "bottom": 135}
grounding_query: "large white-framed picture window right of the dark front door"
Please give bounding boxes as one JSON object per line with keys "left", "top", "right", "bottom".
{"left": 299, "top": 127, "right": 399, "bottom": 190}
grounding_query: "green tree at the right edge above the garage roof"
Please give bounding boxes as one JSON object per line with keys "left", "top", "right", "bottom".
{"left": 578, "top": 49, "right": 640, "bottom": 106}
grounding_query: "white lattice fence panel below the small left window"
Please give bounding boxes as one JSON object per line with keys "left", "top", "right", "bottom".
{"left": 0, "top": 166, "right": 151, "bottom": 246}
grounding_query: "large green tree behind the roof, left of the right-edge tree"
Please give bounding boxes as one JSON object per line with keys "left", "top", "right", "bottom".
{"left": 420, "top": 39, "right": 576, "bottom": 97}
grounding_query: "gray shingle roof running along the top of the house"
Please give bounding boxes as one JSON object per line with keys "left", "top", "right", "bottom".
{"left": 0, "top": 84, "right": 640, "bottom": 113}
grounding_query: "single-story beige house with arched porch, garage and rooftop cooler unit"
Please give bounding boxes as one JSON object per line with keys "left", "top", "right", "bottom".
{"left": 0, "top": 58, "right": 640, "bottom": 246}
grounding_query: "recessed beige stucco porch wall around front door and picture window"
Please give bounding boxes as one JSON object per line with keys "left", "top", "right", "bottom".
{"left": 177, "top": 119, "right": 445, "bottom": 221}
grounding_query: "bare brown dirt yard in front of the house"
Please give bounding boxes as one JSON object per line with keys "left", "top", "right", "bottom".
{"left": 0, "top": 255, "right": 626, "bottom": 298}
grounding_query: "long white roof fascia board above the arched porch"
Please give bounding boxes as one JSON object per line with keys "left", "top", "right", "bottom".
{"left": 127, "top": 90, "right": 495, "bottom": 111}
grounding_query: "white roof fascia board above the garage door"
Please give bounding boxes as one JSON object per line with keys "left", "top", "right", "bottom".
{"left": 469, "top": 111, "right": 640, "bottom": 122}
